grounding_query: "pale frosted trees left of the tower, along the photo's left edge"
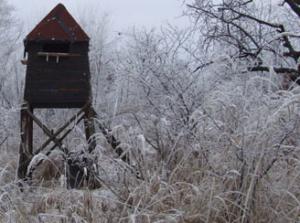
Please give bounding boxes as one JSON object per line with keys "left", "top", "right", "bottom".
{"left": 0, "top": 0, "right": 24, "bottom": 151}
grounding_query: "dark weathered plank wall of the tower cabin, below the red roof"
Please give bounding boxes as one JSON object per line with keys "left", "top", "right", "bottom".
{"left": 24, "top": 42, "right": 91, "bottom": 108}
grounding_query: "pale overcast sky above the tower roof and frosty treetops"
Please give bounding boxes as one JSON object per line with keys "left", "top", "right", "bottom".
{"left": 8, "top": 0, "right": 186, "bottom": 34}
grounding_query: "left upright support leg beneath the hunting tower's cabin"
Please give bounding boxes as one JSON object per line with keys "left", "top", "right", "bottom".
{"left": 18, "top": 104, "right": 33, "bottom": 179}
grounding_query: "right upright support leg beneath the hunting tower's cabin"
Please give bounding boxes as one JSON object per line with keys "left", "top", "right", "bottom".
{"left": 84, "top": 105, "right": 96, "bottom": 152}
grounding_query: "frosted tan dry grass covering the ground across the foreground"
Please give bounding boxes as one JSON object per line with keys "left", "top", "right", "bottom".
{"left": 0, "top": 132, "right": 300, "bottom": 223}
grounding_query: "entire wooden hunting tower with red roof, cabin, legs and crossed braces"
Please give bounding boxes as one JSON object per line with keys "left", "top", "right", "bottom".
{"left": 18, "top": 4, "right": 95, "bottom": 186}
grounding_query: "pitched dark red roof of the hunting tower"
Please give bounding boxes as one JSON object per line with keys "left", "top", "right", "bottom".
{"left": 26, "top": 4, "right": 89, "bottom": 42}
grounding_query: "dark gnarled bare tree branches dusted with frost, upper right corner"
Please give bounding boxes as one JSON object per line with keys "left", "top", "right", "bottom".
{"left": 188, "top": 0, "right": 300, "bottom": 85}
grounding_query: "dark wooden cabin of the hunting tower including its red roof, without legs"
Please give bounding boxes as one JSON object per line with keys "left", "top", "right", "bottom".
{"left": 24, "top": 4, "right": 91, "bottom": 108}
